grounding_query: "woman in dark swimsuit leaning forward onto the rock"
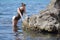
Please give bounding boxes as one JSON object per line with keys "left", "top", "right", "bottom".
{"left": 12, "top": 3, "right": 26, "bottom": 32}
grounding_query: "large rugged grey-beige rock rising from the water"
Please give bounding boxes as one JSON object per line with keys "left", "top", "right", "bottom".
{"left": 23, "top": 0, "right": 60, "bottom": 32}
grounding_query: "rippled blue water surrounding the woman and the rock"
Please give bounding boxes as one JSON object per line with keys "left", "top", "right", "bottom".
{"left": 0, "top": 0, "right": 59, "bottom": 40}
